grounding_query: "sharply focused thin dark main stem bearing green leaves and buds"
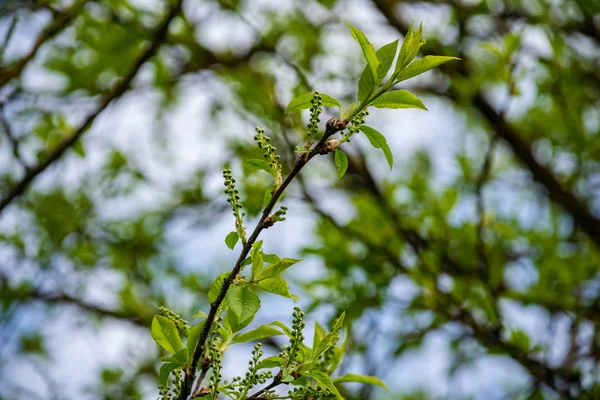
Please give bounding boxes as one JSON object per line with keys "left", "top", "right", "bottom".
{"left": 178, "top": 122, "right": 343, "bottom": 400}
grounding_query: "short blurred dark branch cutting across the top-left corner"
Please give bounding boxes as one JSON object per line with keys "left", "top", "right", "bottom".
{"left": 0, "top": 0, "right": 86, "bottom": 88}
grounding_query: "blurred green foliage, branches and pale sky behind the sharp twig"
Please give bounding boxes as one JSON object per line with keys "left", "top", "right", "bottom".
{"left": 0, "top": 0, "right": 600, "bottom": 400}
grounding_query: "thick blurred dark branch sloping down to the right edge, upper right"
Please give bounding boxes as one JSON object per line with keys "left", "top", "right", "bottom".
{"left": 373, "top": 0, "right": 600, "bottom": 247}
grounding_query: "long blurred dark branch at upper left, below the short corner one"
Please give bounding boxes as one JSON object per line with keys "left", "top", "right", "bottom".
{"left": 0, "top": 0, "right": 183, "bottom": 213}
